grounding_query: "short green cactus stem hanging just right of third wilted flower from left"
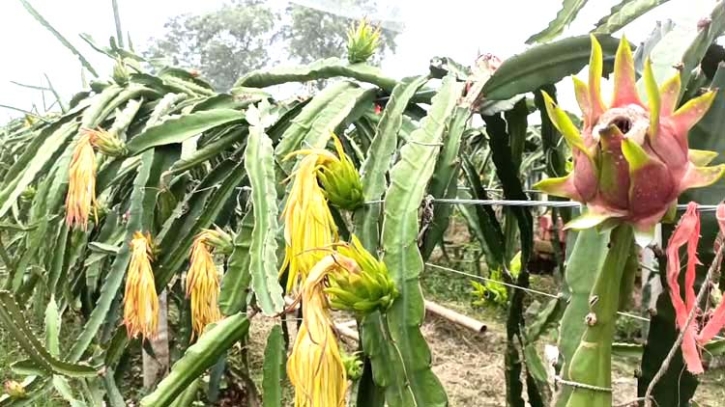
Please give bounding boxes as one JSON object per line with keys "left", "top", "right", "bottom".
{"left": 219, "top": 211, "right": 254, "bottom": 315}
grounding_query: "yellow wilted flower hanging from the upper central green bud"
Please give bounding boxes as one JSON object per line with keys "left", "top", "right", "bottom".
{"left": 281, "top": 152, "right": 337, "bottom": 292}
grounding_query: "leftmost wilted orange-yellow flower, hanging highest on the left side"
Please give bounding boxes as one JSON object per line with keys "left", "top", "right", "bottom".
{"left": 65, "top": 132, "right": 97, "bottom": 231}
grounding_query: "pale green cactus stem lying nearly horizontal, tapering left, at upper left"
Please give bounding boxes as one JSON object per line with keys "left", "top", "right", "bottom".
{"left": 126, "top": 109, "right": 244, "bottom": 155}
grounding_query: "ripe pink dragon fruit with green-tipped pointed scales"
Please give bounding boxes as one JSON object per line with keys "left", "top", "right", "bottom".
{"left": 535, "top": 35, "right": 725, "bottom": 246}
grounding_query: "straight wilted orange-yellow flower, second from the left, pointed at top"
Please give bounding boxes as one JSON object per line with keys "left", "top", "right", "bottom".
{"left": 123, "top": 232, "right": 159, "bottom": 339}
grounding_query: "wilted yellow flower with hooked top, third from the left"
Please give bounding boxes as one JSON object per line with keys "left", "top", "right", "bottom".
{"left": 186, "top": 230, "right": 231, "bottom": 335}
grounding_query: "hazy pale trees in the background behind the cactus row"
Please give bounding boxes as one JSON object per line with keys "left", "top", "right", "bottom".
{"left": 145, "top": 0, "right": 398, "bottom": 91}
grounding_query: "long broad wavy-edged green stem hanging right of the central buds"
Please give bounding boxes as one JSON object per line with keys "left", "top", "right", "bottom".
{"left": 370, "top": 76, "right": 464, "bottom": 407}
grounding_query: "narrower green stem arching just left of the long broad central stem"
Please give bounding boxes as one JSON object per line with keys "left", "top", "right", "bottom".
{"left": 355, "top": 76, "right": 429, "bottom": 252}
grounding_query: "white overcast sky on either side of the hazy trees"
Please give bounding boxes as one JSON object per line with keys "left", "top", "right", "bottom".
{"left": 0, "top": 0, "right": 716, "bottom": 123}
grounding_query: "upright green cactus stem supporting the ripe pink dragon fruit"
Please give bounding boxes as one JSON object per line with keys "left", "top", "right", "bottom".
{"left": 556, "top": 224, "right": 635, "bottom": 407}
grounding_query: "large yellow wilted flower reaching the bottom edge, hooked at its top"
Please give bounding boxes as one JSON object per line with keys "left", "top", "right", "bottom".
{"left": 287, "top": 255, "right": 348, "bottom": 407}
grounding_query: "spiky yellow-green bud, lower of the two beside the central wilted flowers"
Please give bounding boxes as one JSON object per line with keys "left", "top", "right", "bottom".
{"left": 325, "top": 235, "right": 399, "bottom": 314}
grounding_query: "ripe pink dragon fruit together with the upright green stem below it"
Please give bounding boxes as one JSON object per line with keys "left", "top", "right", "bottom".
{"left": 536, "top": 36, "right": 725, "bottom": 407}
